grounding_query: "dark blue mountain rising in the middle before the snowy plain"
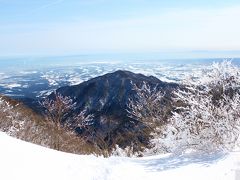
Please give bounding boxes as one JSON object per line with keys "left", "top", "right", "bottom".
{"left": 47, "top": 70, "right": 179, "bottom": 150}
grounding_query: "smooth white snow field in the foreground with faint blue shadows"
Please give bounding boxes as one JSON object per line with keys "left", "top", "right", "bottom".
{"left": 0, "top": 133, "right": 240, "bottom": 180}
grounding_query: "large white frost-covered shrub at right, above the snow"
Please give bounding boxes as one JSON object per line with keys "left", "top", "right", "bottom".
{"left": 152, "top": 61, "right": 240, "bottom": 153}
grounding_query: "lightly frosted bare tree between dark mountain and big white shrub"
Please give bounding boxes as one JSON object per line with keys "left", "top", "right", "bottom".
{"left": 122, "top": 82, "right": 171, "bottom": 155}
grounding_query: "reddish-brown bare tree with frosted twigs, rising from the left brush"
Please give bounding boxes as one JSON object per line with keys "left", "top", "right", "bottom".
{"left": 41, "top": 92, "right": 97, "bottom": 154}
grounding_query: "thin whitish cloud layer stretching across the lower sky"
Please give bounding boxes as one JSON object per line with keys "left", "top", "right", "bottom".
{"left": 0, "top": 5, "right": 240, "bottom": 55}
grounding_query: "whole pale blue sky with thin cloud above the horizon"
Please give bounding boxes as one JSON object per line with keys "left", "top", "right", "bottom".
{"left": 0, "top": 0, "right": 240, "bottom": 57}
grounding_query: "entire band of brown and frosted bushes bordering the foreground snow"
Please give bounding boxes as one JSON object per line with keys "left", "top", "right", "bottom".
{"left": 0, "top": 61, "right": 240, "bottom": 156}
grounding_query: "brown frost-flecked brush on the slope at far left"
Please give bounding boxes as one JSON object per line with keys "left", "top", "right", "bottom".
{"left": 0, "top": 97, "right": 94, "bottom": 154}
